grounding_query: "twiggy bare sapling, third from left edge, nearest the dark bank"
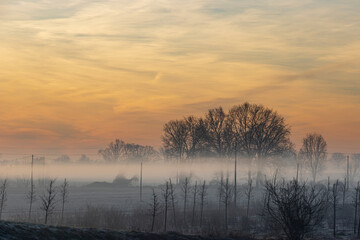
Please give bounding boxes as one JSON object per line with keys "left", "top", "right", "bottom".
{"left": 40, "top": 179, "right": 57, "bottom": 224}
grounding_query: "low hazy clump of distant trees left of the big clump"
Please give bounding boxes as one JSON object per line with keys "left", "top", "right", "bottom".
{"left": 99, "top": 139, "right": 158, "bottom": 162}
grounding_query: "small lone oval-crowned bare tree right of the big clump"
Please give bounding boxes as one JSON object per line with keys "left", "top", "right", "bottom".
{"left": 300, "top": 133, "right": 327, "bottom": 182}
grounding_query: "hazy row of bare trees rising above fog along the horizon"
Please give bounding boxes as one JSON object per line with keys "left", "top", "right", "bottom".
{"left": 99, "top": 102, "right": 360, "bottom": 186}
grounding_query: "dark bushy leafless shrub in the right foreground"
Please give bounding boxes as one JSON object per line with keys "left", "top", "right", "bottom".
{"left": 265, "top": 180, "right": 326, "bottom": 240}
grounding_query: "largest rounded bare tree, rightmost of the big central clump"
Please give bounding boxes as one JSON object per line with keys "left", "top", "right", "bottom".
{"left": 229, "top": 103, "right": 293, "bottom": 186}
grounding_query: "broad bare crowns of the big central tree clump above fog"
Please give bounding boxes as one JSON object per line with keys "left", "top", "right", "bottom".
{"left": 162, "top": 103, "right": 293, "bottom": 159}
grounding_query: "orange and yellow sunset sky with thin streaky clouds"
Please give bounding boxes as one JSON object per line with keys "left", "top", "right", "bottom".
{"left": 0, "top": 0, "right": 360, "bottom": 153}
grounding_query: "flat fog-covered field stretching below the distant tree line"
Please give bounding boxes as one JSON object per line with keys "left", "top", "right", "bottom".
{"left": 1, "top": 160, "right": 357, "bottom": 238}
